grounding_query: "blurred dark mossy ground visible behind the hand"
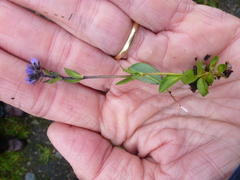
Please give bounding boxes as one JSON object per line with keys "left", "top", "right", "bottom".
{"left": 0, "top": 0, "right": 240, "bottom": 180}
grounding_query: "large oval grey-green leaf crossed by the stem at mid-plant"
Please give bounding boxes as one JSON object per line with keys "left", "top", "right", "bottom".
{"left": 128, "top": 63, "right": 162, "bottom": 84}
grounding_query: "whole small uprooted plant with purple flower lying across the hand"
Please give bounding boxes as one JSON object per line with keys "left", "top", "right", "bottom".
{"left": 26, "top": 55, "right": 233, "bottom": 112}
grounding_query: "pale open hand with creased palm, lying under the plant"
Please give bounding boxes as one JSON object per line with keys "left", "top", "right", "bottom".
{"left": 0, "top": 0, "right": 240, "bottom": 180}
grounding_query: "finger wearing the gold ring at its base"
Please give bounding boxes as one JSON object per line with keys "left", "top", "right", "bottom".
{"left": 7, "top": 0, "right": 132, "bottom": 55}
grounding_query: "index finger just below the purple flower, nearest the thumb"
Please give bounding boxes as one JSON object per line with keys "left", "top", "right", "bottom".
{"left": 0, "top": 50, "right": 104, "bottom": 131}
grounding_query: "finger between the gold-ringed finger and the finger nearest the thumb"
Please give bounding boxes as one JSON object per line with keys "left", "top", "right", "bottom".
{"left": 0, "top": 1, "right": 120, "bottom": 91}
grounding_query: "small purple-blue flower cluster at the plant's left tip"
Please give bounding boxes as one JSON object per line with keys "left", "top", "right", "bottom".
{"left": 26, "top": 58, "right": 43, "bottom": 85}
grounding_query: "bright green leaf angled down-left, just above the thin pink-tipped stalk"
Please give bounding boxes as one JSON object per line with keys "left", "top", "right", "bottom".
{"left": 158, "top": 75, "right": 182, "bottom": 93}
